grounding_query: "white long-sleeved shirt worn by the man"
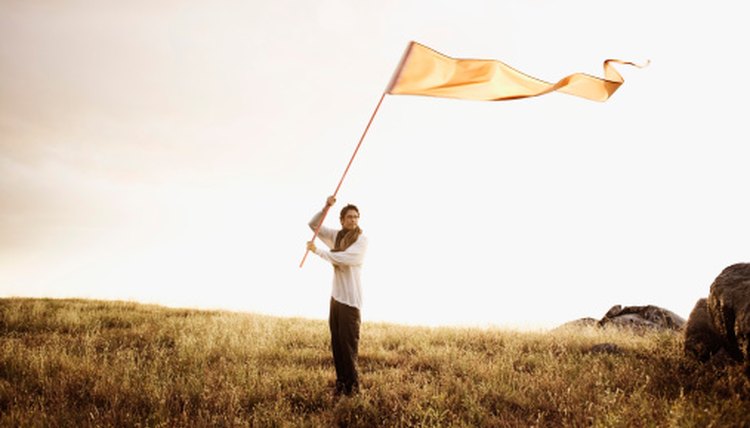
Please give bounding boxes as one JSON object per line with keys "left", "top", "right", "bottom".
{"left": 308, "top": 211, "right": 367, "bottom": 309}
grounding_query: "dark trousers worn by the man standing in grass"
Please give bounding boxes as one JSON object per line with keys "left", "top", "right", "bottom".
{"left": 328, "top": 299, "right": 360, "bottom": 394}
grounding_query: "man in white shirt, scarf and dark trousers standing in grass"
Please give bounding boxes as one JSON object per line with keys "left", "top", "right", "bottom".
{"left": 307, "top": 196, "right": 367, "bottom": 395}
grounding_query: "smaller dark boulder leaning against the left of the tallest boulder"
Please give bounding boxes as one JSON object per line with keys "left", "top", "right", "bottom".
{"left": 684, "top": 299, "right": 727, "bottom": 362}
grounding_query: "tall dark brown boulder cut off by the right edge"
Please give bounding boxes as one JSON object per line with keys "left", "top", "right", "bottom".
{"left": 708, "top": 263, "right": 750, "bottom": 365}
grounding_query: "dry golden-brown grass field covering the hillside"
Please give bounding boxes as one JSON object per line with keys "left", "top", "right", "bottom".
{"left": 0, "top": 299, "right": 750, "bottom": 427}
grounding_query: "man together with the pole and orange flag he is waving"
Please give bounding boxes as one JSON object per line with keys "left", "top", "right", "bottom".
{"left": 300, "top": 42, "right": 642, "bottom": 395}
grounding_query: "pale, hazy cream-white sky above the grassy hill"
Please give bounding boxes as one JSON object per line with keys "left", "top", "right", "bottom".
{"left": 0, "top": 0, "right": 750, "bottom": 329}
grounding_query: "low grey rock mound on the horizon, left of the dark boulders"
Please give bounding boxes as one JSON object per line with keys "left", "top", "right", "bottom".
{"left": 599, "top": 305, "right": 685, "bottom": 330}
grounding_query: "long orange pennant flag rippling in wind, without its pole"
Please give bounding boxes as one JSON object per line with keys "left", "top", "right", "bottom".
{"left": 386, "top": 42, "right": 643, "bottom": 101}
